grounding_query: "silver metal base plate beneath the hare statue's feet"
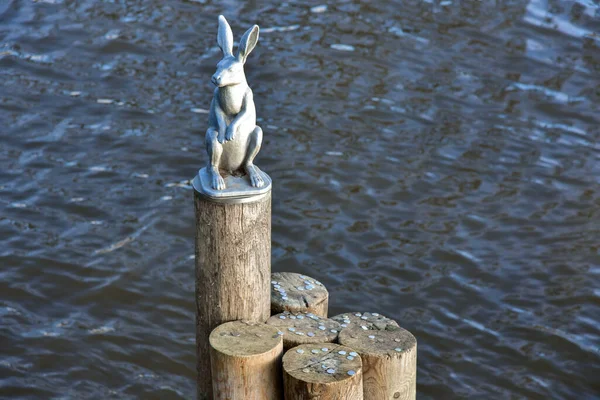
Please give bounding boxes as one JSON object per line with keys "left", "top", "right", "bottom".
{"left": 192, "top": 166, "right": 272, "bottom": 204}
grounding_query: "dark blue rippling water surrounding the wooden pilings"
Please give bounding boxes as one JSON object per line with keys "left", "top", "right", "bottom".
{"left": 0, "top": 0, "right": 600, "bottom": 399}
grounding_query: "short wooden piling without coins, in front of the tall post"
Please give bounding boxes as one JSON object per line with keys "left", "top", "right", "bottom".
{"left": 209, "top": 321, "right": 283, "bottom": 400}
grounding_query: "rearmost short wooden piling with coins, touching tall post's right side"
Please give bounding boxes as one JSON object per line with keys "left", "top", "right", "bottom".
{"left": 271, "top": 272, "right": 329, "bottom": 318}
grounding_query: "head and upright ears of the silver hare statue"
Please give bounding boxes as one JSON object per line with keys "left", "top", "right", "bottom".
{"left": 212, "top": 15, "right": 258, "bottom": 87}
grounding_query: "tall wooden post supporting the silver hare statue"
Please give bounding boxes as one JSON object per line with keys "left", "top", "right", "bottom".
{"left": 194, "top": 191, "right": 271, "bottom": 399}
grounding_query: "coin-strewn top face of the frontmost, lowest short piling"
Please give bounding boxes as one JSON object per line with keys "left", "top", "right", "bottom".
{"left": 283, "top": 343, "right": 362, "bottom": 384}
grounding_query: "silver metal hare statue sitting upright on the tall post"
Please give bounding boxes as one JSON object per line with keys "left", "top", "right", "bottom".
{"left": 206, "top": 15, "right": 264, "bottom": 190}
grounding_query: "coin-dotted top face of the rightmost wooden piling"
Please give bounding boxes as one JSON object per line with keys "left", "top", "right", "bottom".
{"left": 338, "top": 324, "right": 417, "bottom": 358}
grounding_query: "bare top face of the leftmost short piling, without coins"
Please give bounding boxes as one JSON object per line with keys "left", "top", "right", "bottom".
{"left": 209, "top": 321, "right": 282, "bottom": 357}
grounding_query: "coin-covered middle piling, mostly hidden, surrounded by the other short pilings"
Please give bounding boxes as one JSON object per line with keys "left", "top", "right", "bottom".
{"left": 267, "top": 311, "right": 341, "bottom": 351}
